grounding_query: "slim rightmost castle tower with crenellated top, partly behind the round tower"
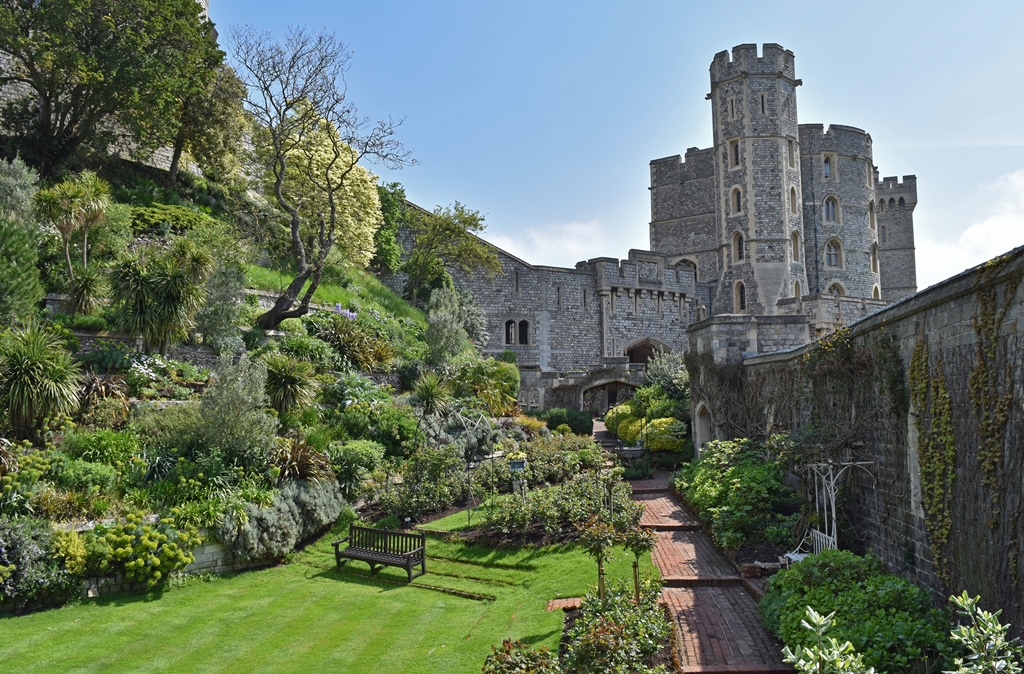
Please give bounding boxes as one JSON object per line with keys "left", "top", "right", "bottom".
{"left": 874, "top": 175, "right": 918, "bottom": 302}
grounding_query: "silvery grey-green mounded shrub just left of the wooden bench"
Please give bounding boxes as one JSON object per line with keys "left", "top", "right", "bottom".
{"left": 217, "top": 480, "right": 345, "bottom": 561}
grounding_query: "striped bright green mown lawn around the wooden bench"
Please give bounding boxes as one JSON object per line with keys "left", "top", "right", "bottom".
{"left": 0, "top": 513, "right": 656, "bottom": 674}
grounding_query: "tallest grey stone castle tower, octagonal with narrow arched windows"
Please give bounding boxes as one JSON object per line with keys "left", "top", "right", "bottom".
{"left": 708, "top": 44, "right": 807, "bottom": 314}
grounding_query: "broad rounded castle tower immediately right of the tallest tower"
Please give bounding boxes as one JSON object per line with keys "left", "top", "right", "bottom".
{"left": 800, "top": 124, "right": 883, "bottom": 299}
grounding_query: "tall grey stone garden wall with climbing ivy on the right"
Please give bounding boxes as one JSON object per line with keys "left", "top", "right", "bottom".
{"left": 689, "top": 243, "right": 1024, "bottom": 634}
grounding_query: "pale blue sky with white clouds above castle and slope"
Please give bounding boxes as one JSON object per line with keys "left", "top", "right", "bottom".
{"left": 210, "top": 0, "right": 1024, "bottom": 288}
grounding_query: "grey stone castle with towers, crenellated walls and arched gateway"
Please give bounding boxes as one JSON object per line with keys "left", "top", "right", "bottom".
{"left": 425, "top": 44, "right": 918, "bottom": 411}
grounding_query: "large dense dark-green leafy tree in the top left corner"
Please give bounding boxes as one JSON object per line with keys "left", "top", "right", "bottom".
{"left": 0, "top": 0, "right": 223, "bottom": 176}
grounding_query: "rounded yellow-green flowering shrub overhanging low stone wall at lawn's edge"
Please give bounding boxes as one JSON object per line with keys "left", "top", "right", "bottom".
{"left": 86, "top": 513, "right": 201, "bottom": 589}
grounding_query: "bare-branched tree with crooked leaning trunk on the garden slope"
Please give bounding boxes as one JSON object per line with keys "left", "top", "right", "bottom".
{"left": 231, "top": 27, "right": 411, "bottom": 329}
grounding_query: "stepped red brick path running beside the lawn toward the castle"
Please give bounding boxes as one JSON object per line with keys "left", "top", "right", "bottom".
{"left": 631, "top": 475, "right": 794, "bottom": 674}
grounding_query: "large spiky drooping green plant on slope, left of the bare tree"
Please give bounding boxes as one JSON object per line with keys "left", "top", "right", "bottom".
{"left": 111, "top": 239, "right": 213, "bottom": 355}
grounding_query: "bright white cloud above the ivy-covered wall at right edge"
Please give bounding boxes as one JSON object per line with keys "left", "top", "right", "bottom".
{"left": 916, "top": 170, "right": 1024, "bottom": 289}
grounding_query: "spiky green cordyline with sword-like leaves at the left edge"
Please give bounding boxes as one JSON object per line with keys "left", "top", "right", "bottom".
{"left": 0, "top": 323, "right": 82, "bottom": 437}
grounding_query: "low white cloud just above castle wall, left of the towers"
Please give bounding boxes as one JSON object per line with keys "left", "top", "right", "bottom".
{"left": 484, "top": 220, "right": 647, "bottom": 267}
